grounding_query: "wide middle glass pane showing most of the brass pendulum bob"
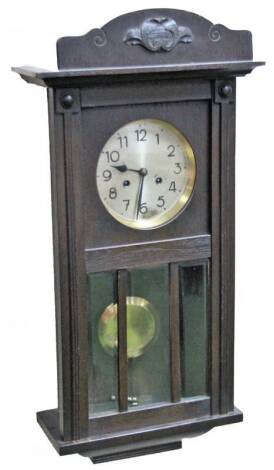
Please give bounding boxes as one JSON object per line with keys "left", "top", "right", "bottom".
{"left": 127, "top": 265, "right": 170, "bottom": 408}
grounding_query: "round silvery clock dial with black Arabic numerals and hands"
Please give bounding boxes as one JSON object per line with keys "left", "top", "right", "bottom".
{"left": 96, "top": 119, "right": 196, "bottom": 229}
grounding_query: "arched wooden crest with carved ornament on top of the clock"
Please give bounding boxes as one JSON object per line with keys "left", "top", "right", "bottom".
{"left": 57, "top": 8, "right": 252, "bottom": 70}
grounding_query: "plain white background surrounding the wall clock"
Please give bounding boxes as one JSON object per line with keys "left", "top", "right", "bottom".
{"left": 0, "top": 0, "right": 274, "bottom": 470}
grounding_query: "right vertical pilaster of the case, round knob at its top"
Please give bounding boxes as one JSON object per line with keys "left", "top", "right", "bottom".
{"left": 211, "top": 78, "right": 236, "bottom": 414}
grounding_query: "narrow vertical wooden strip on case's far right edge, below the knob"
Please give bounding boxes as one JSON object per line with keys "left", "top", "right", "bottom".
{"left": 220, "top": 93, "right": 235, "bottom": 413}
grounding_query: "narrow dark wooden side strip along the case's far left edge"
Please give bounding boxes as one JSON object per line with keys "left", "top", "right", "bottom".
{"left": 48, "top": 90, "right": 73, "bottom": 441}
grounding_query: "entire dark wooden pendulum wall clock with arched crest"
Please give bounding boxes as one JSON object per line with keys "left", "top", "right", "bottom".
{"left": 14, "top": 9, "right": 263, "bottom": 463}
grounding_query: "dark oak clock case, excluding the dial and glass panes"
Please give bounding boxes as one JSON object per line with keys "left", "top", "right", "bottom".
{"left": 14, "top": 9, "right": 263, "bottom": 462}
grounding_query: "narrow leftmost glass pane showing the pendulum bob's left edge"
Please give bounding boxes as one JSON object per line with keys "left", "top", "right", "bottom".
{"left": 88, "top": 272, "right": 118, "bottom": 415}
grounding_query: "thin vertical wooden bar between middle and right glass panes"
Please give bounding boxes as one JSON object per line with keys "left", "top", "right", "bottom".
{"left": 169, "top": 263, "right": 181, "bottom": 402}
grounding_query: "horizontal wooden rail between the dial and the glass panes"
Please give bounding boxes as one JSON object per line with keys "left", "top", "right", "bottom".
{"left": 86, "top": 235, "right": 211, "bottom": 273}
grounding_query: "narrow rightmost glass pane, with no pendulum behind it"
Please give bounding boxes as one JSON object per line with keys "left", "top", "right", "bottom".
{"left": 181, "top": 265, "right": 208, "bottom": 398}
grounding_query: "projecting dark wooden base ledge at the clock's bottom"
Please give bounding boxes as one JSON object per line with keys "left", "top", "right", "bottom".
{"left": 37, "top": 408, "right": 243, "bottom": 463}
